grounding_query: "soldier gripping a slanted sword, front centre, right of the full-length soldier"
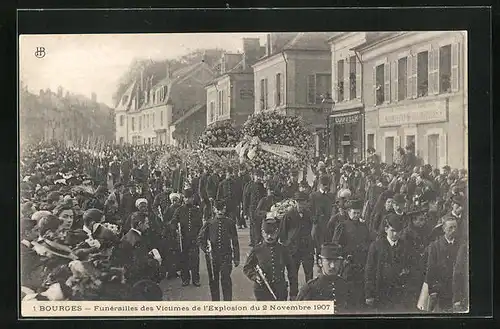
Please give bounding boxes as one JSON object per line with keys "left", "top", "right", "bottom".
{"left": 243, "top": 213, "right": 298, "bottom": 301}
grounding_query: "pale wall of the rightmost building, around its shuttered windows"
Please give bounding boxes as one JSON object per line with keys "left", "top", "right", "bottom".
{"left": 362, "top": 32, "right": 468, "bottom": 168}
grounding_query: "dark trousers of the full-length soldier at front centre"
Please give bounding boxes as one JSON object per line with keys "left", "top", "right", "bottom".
{"left": 205, "top": 253, "right": 233, "bottom": 301}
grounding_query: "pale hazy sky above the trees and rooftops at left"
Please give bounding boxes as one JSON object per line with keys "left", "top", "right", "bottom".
{"left": 19, "top": 33, "right": 266, "bottom": 107}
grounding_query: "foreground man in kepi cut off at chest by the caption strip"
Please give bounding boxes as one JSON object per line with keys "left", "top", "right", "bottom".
{"left": 297, "top": 243, "right": 348, "bottom": 314}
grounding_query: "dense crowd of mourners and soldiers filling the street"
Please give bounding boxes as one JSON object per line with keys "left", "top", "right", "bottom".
{"left": 20, "top": 140, "right": 468, "bottom": 313}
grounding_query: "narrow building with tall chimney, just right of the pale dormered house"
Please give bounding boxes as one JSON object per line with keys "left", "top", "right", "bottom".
{"left": 206, "top": 38, "right": 262, "bottom": 126}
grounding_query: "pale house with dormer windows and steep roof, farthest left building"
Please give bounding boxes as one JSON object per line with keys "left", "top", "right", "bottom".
{"left": 115, "top": 61, "right": 214, "bottom": 145}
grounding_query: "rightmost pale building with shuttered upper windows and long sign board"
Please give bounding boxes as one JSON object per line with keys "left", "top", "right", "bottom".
{"left": 355, "top": 31, "right": 468, "bottom": 168}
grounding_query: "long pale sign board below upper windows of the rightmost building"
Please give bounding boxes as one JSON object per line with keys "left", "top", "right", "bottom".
{"left": 379, "top": 101, "right": 447, "bottom": 127}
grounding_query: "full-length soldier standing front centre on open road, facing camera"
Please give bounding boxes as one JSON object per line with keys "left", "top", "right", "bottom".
{"left": 198, "top": 200, "right": 240, "bottom": 301}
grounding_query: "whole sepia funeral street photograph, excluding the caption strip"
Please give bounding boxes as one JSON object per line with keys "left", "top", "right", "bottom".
{"left": 18, "top": 31, "right": 469, "bottom": 315}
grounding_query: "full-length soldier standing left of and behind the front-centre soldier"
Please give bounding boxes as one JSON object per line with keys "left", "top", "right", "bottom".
{"left": 171, "top": 189, "right": 203, "bottom": 287}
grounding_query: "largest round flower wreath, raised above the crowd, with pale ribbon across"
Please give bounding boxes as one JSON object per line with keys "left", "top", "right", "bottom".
{"left": 243, "top": 111, "right": 312, "bottom": 176}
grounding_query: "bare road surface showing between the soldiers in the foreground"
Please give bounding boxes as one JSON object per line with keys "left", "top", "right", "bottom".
{"left": 160, "top": 228, "right": 318, "bottom": 301}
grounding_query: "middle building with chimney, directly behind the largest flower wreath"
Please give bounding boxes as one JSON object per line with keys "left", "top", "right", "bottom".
{"left": 253, "top": 33, "right": 332, "bottom": 156}
